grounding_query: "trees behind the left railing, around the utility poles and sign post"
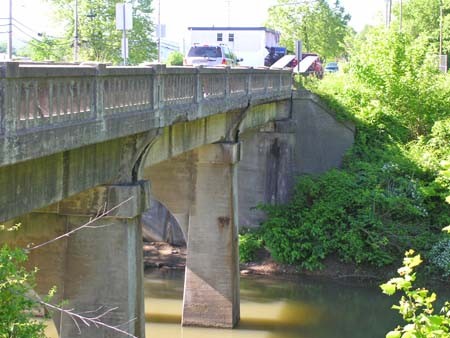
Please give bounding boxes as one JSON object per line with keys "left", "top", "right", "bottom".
{"left": 28, "top": 0, "right": 156, "bottom": 64}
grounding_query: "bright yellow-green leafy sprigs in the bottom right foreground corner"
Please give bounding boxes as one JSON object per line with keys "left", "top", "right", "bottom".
{"left": 380, "top": 250, "right": 450, "bottom": 338}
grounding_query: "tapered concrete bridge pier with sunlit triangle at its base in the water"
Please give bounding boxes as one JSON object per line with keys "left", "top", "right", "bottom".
{"left": 182, "top": 143, "right": 240, "bottom": 328}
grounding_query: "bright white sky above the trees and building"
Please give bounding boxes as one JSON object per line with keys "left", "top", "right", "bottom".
{"left": 0, "top": 0, "right": 385, "bottom": 45}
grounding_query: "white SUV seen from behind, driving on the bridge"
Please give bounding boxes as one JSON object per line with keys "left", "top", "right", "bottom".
{"left": 183, "top": 44, "right": 242, "bottom": 67}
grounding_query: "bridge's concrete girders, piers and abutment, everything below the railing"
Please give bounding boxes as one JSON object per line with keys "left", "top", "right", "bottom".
{"left": 0, "top": 91, "right": 353, "bottom": 338}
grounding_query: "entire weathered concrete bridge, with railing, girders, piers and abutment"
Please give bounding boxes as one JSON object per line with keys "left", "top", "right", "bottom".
{"left": 0, "top": 62, "right": 353, "bottom": 337}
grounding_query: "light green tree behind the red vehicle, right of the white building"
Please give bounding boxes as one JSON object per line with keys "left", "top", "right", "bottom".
{"left": 267, "top": 0, "right": 350, "bottom": 58}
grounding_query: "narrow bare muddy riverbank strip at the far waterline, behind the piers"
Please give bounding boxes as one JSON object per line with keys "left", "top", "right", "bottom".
{"left": 143, "top": 242, "right": 395, "bottom": 284}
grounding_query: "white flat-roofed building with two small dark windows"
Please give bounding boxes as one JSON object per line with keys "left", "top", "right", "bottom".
{"left": 188, "top": 26, "right": 280, "bottom": 67}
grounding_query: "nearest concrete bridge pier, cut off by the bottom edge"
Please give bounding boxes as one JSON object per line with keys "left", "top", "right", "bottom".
{"left": 48, "top": 182, "right": 149, "bottom": 338}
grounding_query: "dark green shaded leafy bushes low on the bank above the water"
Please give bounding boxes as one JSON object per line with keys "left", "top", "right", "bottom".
{"left": 262, "top": 162, "right": 440, "bottom": 270}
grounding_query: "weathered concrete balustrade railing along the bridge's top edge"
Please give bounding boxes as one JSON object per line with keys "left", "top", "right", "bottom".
{"left": 0, "top": 62, "right": 292, "bottom": 163}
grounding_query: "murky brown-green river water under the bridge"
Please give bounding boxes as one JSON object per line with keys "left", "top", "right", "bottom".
{"left": 45, "top": 271, "right": 401, "bottom": 338}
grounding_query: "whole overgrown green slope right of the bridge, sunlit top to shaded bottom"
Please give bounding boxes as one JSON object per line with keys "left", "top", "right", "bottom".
{"left": 240, "top": 29, "right": 450, "bottom": 277}
